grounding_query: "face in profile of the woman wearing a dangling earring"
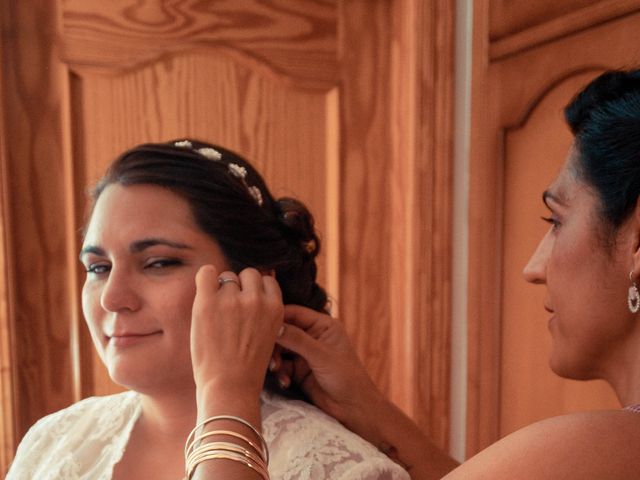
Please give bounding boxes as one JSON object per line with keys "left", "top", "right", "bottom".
{"left": 524, "top": 149, "right": 634, "bottom": 379}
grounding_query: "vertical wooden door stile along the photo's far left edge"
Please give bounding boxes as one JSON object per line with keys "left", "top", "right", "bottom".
{"left": 0, "top": 2, "right": 76, "bottom": 468}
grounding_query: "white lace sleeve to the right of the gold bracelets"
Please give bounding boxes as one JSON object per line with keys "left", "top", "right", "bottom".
{"left": 262, "top": 395, "right": 409, "bottom": 480}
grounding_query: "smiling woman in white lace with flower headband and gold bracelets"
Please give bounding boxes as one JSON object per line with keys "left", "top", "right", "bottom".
{"left": 7, "top": 140, "right": 408, "bottom": 480}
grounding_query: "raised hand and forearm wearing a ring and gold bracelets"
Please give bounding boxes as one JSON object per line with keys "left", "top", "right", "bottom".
{"left": 186, "top": 266, "right": 284, "bottom": 480}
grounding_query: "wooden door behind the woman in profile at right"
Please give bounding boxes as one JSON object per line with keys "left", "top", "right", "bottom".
{"left": 468, "top": 1, "right": 640, "bottom": 454}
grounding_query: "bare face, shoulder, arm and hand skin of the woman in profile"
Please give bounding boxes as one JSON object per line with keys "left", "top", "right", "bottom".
{"left": 278, "top": 150, "right": 640, "bottom": 480}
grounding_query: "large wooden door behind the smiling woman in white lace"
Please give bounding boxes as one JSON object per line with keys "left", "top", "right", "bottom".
{"left": 0, "top": 0, "right": 453, "bottom": 470}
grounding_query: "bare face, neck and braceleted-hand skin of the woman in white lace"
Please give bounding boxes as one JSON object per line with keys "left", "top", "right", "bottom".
{"left": 80, "top": 184, "right": 283, "bottom": 480}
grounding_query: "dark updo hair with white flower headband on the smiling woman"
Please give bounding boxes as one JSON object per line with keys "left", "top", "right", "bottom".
{"left": 93, "top": 140, "right": 327, "bottom": 396}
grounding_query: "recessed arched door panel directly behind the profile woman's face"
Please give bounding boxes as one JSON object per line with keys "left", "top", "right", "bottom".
{"left": 500, "top": 74, "right": 617, "bottom": 436}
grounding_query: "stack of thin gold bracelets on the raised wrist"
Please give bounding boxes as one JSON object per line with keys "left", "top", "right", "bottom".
{"left": 184, "top": 415, "right": 269, "bottom": 480}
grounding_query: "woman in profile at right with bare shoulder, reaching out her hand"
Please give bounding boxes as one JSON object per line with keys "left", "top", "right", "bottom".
{"left": 278, "top": 70, "right": 640, "bottom": 480}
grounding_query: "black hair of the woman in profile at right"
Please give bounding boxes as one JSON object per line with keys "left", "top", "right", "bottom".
{"left": 564, "top": 70, "right": 640, "bottom": 231}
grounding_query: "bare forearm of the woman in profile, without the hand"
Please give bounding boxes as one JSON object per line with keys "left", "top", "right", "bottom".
{"left": 347, "top": 396, "right": 458, "bottom": 480}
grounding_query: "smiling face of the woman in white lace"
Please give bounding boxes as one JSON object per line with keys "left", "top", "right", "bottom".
{"left": 80, "top": 184, "right": 226, "bottom": 392}
